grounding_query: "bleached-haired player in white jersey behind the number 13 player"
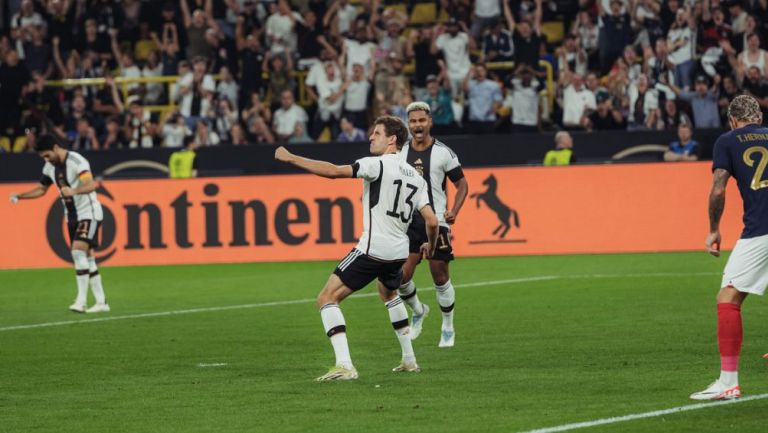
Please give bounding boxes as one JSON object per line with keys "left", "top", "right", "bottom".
{"left": 399, "top": 102, "right": 469, "bottom": 347}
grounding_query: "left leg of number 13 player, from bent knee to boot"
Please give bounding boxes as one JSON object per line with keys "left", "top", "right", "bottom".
{"left": 317, "top": 274, "right": 357, "bottom": 381}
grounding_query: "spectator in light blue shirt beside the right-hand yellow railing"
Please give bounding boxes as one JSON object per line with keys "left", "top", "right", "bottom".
{"left": 464, "top": 63, "right": 503, "bottom": 134}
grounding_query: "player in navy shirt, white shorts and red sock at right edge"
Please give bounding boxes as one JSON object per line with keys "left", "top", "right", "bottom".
{"left": 691, "top": 95, "right": 768, "bottom": 400}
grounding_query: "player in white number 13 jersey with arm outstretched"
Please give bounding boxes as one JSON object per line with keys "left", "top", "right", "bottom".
{"left": 275, "top": 116, "right": 438, "bottom": 381}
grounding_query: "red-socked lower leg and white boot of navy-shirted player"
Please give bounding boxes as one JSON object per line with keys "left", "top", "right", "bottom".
{"left": 691, "top": 287, "right": 747, "bottom": 400}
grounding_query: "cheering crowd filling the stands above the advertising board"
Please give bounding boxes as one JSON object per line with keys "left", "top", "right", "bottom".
{"left": 0, "top": 0, "right": 768, "bottom": 152}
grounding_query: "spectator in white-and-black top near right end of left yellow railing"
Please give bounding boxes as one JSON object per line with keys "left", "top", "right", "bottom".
{"left": 178, "top": 57, "right": 216, "bottom": 129}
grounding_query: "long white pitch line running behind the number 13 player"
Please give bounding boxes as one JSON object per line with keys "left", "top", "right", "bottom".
{"left": 0, "top": 273, "right": 719, "bottom": 332}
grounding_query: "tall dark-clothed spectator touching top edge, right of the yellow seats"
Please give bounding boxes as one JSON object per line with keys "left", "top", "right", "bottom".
{"left": 597, "top": 0, "right": 632, "bottom": 75}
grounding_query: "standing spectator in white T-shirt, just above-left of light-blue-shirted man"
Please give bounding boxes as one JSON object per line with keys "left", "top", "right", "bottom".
{"left": 431, "top": 17, "right": 475, "bottom": 98}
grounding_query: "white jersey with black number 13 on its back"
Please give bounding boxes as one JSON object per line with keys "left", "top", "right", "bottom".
{"left": 352, "top": 154, "right": 429, "bottom": 261}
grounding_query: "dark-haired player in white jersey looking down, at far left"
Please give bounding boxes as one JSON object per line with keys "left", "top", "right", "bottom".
{"left": 11, "top": 135, "right": 109, "bottom": 313}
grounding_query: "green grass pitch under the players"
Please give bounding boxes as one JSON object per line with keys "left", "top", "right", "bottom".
{"left": 0, "top": 253, "right": 768, "bottom": 433}
